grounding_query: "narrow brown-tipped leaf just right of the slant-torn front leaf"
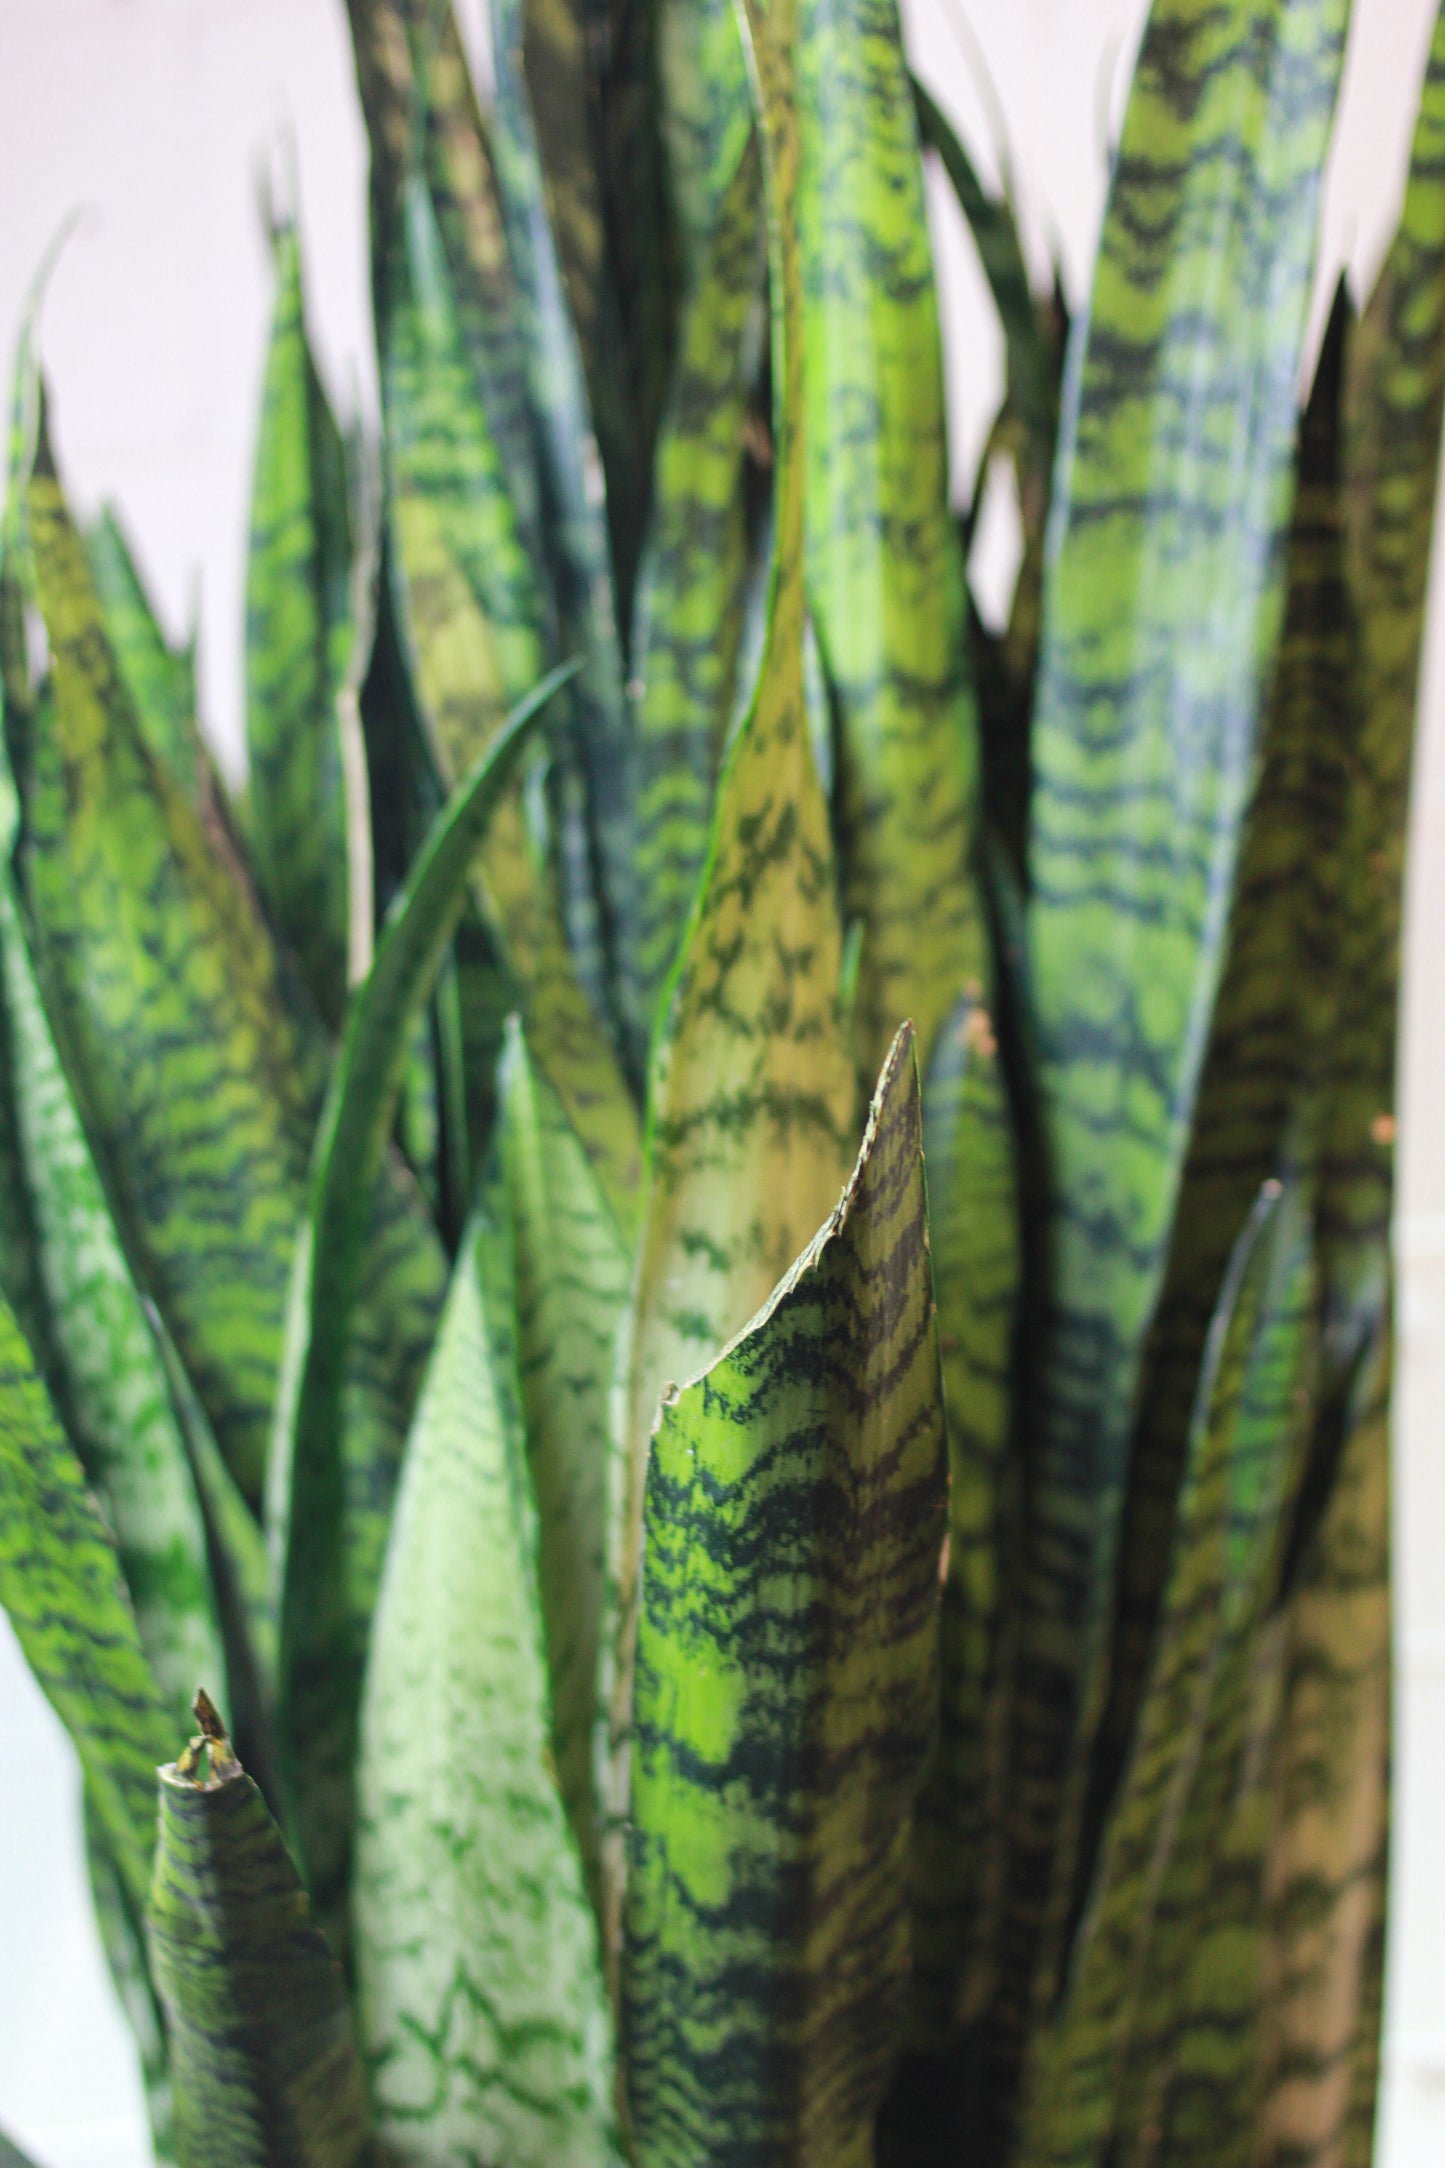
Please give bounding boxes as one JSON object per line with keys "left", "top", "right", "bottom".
{"left": 910, "top": 995, "right": 1023, "bottom": 2053}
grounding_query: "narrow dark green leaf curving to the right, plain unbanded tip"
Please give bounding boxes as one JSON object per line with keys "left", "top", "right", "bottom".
{"left": 266, "top": 670, "right": 568, "bottom": 1933}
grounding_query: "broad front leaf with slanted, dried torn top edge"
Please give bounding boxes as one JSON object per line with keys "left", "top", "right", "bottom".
{"left": 624, "top": 1030, "right": 947, "bottom": 2168}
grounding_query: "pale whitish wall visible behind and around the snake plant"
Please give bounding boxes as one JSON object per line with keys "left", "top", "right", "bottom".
{"left": 0, "top": 0, "right": 1445, "bottom": 2168}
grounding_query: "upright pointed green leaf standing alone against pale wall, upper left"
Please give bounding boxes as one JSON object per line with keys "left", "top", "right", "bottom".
{"left": 245, "top": 223, "right": 353, "bottom": 1030}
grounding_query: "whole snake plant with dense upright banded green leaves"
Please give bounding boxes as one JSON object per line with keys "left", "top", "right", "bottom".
{"left": 0, "top": 0, "right": 1445, "bottom": 2168}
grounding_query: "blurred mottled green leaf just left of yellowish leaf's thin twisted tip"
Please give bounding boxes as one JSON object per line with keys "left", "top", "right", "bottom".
{"left": 620, "top": 135, "right": 765, "bottom": 1049}
